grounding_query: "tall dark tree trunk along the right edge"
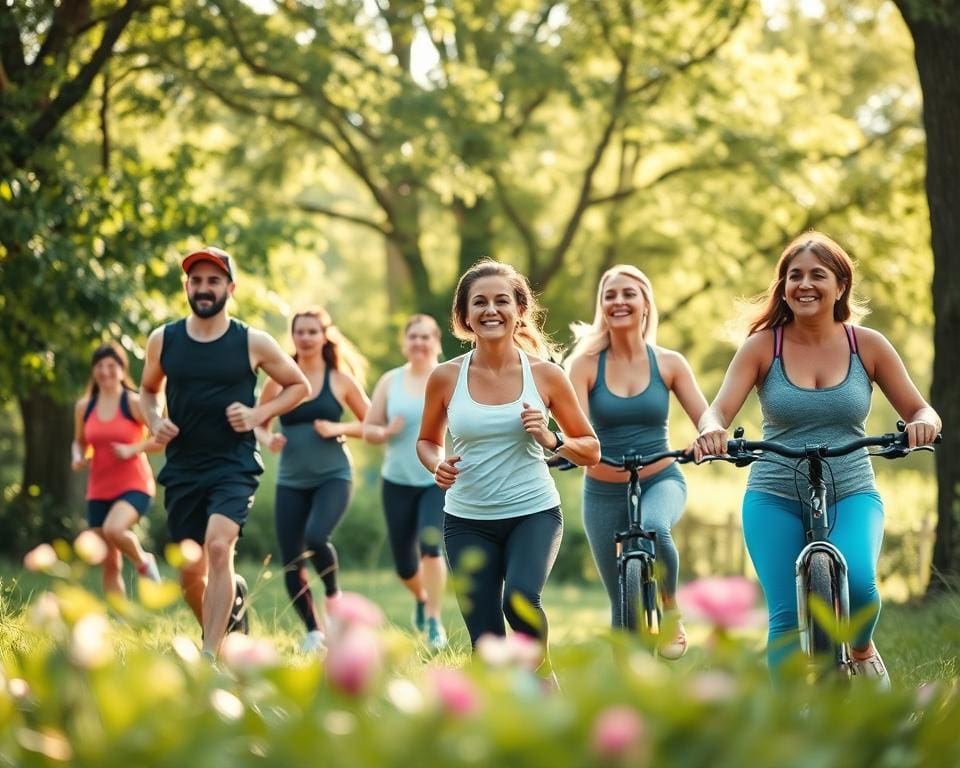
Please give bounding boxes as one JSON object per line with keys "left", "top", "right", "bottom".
{"left": 898, "top": 7, "right": 960, "bottom": 590}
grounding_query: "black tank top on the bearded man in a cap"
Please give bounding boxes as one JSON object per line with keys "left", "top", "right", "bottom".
{"left": 160, "top": 319, "right": 263, "bottom": 479}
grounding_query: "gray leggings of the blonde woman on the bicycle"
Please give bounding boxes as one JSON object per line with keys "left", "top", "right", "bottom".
{"left": 583, "top": 465, "right": 687, "bottom": 627}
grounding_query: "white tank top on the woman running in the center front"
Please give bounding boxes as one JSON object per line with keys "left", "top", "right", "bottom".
{"left": 444, "top": 350, "right": 560, "bottom": 520}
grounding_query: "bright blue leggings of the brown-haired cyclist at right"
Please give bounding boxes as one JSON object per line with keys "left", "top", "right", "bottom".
{"left": 743, "top": 491, "right": 883, "bottom": 677}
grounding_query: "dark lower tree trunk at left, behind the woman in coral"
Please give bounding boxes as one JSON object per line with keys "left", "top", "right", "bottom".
{"left": 0, "top": 392, "right": 84, "bottom": 556}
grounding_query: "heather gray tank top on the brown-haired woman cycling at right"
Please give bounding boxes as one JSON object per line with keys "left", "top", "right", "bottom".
{"left": 747, "top": 325, "right": 876, "bottom": 503}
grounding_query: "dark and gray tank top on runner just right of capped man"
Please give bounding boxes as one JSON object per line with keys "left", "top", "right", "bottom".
{"left": 277, "top": 366, "right": 353, "bottom": 488}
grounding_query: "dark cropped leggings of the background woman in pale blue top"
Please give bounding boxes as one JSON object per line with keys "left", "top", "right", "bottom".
{"left": 381, "top": 478, "right": 443, "bottom": 580}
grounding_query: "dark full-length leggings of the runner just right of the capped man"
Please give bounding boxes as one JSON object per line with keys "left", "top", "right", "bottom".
{"left": 274, "top": 478, "right": 353, "bottom": 630}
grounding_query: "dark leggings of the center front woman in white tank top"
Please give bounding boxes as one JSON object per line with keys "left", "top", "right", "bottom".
{"left": 443, "top": 507, "right": 563, "bottom": 646}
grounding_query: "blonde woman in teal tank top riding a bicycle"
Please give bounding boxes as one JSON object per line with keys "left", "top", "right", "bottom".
{"left": 568, "top": 264, "right": 707, "bottom": 659}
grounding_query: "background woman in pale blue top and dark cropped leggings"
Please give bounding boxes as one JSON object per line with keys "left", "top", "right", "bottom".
{"left": 363, "top": 314, "right": 447, "bottom": 650}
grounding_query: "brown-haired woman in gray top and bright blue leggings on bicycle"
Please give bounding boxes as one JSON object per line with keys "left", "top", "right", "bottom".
{"left": 694, "top": 232, "right": 940, "bottom": 687}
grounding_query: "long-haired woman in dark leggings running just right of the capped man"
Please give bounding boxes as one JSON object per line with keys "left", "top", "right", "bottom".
{"left": 257, "top": 307, "right": 370, "bottom": 651}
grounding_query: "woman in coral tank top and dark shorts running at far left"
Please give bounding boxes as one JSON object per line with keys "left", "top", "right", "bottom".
{"left": 72, "top": 342, "right": 160, "bottom": 595}
